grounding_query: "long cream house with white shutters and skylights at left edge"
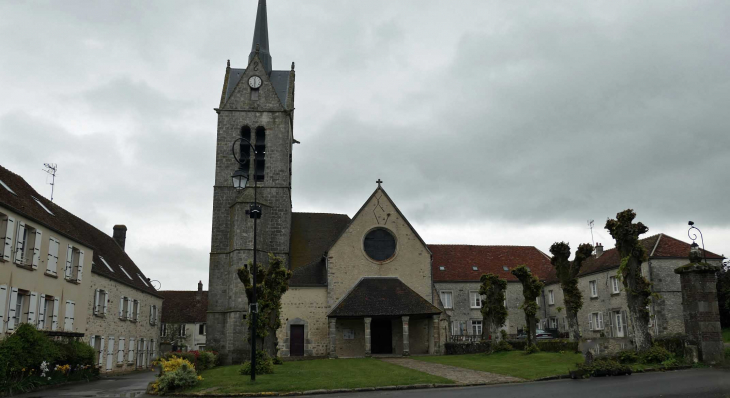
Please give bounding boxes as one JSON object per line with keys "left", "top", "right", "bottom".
{"left": 0, "top": 162, "right": 162, "bottom": 373}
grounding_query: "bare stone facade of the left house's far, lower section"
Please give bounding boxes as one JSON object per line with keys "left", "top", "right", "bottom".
{"left": 85, "top": 273, "right": 162, "bottom": 373}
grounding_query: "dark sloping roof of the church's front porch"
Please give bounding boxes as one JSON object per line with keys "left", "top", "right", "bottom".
{"left": 327, "top": 277, "right": 441, "bottom": 318}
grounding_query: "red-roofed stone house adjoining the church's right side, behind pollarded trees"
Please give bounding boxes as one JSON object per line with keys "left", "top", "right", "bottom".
{"left": 428, "top": 245, "right": 553, "bottom": 340}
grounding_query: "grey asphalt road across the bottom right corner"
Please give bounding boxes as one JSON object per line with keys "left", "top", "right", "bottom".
{"left": 322, "top": 369, "right": 730, "bottom": 398}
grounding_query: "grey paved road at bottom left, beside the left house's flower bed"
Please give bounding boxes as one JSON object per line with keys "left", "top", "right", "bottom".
{"left": 14, "top": 371, "right": 156, "bottom": 398}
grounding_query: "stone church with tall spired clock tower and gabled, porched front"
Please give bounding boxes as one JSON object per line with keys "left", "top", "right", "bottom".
{"left": 207, "top": 0, "right": 445, "bottom": 363}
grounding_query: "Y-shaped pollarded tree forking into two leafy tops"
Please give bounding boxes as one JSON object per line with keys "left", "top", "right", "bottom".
{"left": 550, "top": 242, "right": 593, "bottom": 341}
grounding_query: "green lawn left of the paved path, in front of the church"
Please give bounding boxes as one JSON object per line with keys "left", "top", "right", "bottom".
{"left": 185, "top": 358, "right": 454, "bottom": 393}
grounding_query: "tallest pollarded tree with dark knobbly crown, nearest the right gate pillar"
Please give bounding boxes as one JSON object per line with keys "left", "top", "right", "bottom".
{"left": 606, "top": 209, "right": 652, "bottom": 351}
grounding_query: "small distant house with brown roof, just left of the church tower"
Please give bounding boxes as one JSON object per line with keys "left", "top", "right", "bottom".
{"left": 160, "top": 281, "right": 208, "bottom": 353}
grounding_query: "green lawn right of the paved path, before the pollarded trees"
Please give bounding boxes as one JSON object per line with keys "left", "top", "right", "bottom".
{"left": 413, "top": 351, "right": 583, "bottom": 380}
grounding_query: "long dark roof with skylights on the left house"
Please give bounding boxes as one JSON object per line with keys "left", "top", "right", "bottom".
{"left": 0, "top": 166, "right": 162, "bottom": 297}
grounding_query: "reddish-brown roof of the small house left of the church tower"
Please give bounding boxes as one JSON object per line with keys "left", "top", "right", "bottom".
{"left": 160, "top": 290, "right": 208, "bottom": 323}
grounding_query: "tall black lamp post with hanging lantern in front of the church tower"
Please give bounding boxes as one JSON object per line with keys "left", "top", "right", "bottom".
{"left": 231, "top": 137, "right": 261, "bottom": 381}
